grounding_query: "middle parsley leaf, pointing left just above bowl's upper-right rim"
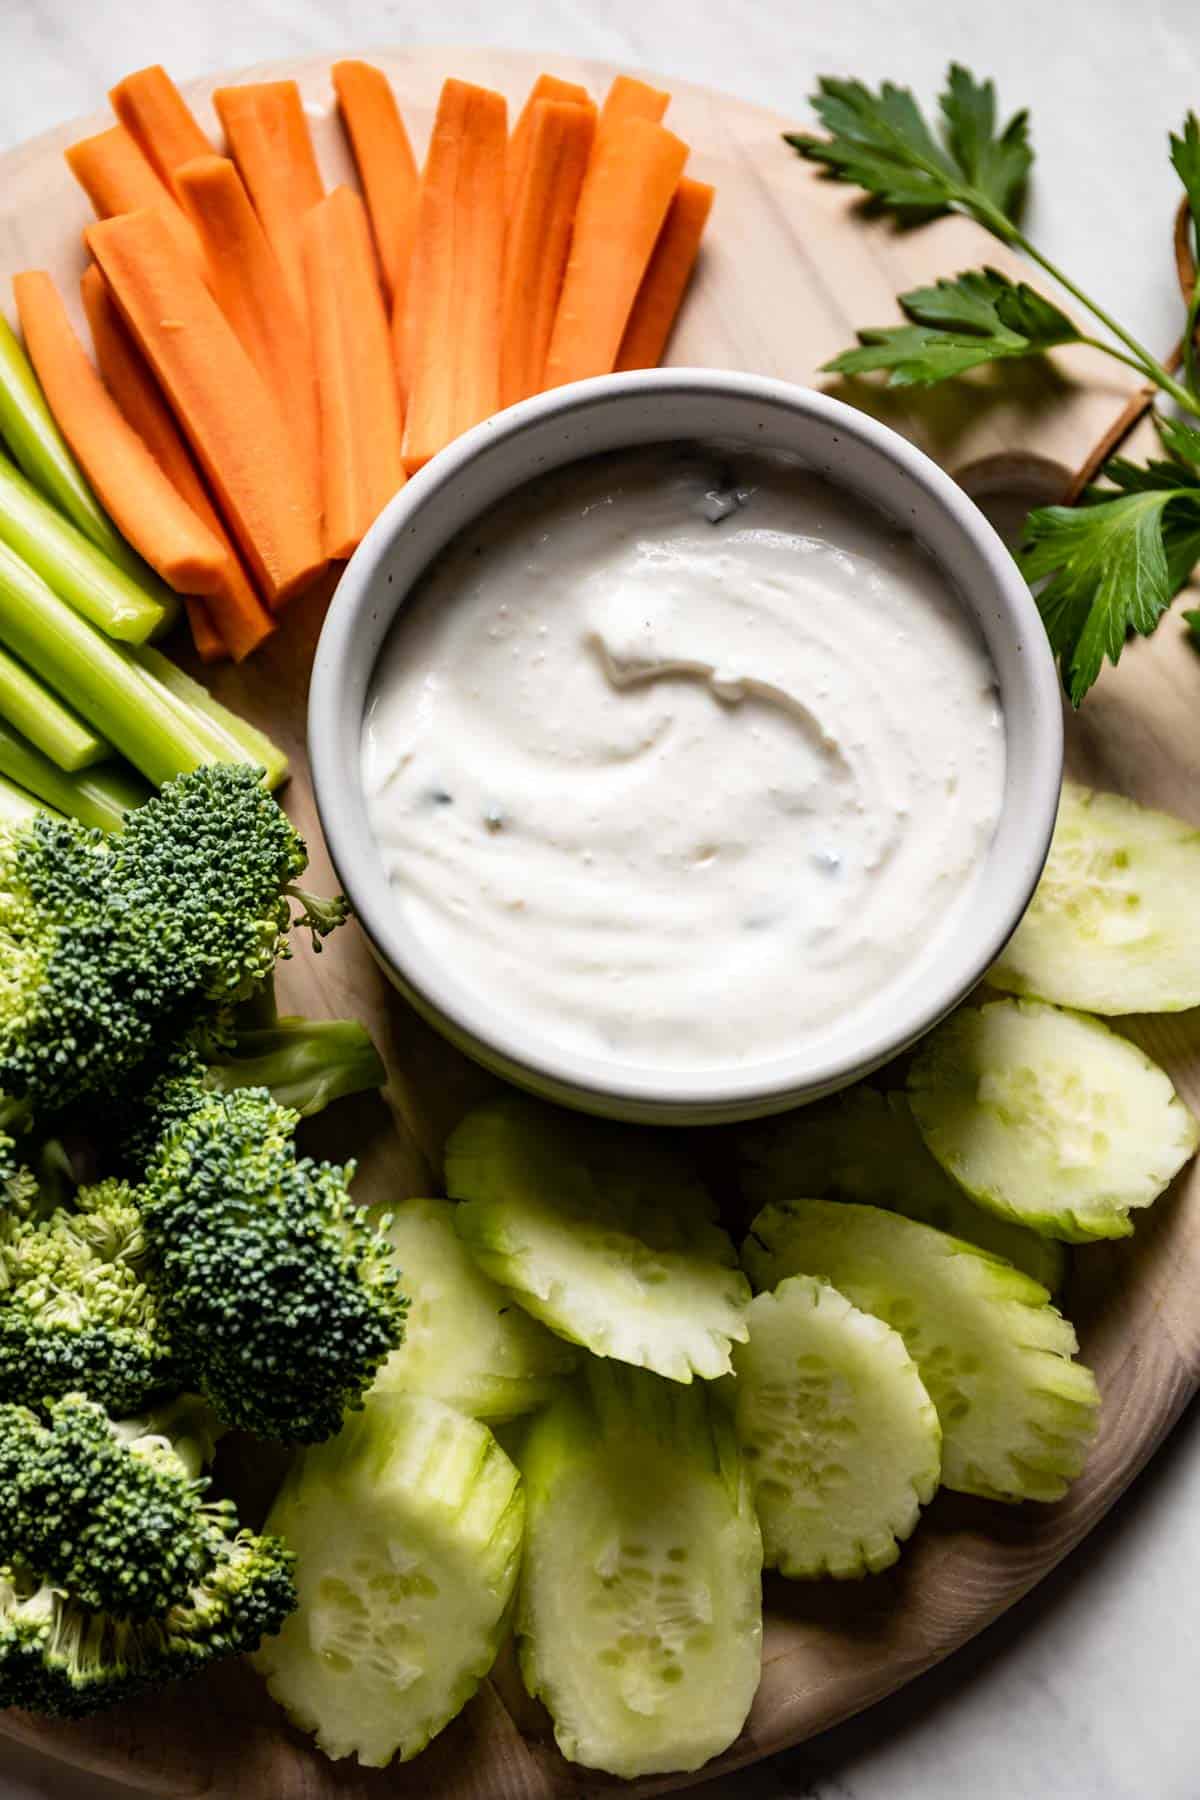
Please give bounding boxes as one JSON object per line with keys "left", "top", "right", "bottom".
{"left": 824, "top": 268, "right": 1079, "bottom": 387}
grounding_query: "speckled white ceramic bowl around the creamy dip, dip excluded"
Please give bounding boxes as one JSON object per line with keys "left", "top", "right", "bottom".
{"left": 309, "top": 369, "right": 1061, "bottom": 1125}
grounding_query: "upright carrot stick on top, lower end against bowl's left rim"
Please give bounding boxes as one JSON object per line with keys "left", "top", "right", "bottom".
{"left": 304, "top": 187, "right": 405, "bottom": 558}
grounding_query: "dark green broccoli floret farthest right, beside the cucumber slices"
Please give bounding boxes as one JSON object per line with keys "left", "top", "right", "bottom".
{"left": 142, "top": 1087, "right": 407, "bottom": 1444}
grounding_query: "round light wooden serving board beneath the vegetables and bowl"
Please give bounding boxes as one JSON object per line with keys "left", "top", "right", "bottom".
{"left": 0, "top": 50, "right": 1200, "bottom": 1800}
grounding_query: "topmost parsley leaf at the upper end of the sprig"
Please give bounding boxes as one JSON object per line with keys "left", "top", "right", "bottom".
{"left": 786, "top": 63, "right": 1033, "bottom": 239}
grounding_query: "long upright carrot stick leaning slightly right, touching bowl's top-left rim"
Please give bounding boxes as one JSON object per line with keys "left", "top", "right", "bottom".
{"left": 403, "top": 81, "right": 507, "bottom": 472}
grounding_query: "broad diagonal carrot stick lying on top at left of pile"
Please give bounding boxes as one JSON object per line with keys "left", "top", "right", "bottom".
{"left": 86, "top": 212, "right": 324, "bottom": 608}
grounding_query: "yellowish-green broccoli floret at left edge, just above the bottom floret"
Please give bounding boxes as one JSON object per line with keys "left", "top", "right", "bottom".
{"left": 0, "top": 1172, "right": 175, "bottom": 1415}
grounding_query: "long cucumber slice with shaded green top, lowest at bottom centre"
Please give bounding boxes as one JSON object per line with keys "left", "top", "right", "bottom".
{"left": 516, "top": 1361, "right": 763, "bottom": 1778}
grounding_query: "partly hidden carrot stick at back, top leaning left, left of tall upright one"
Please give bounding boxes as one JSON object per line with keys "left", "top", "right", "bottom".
{"left": 333, "top": 61, "right": 421, "bottom": 306}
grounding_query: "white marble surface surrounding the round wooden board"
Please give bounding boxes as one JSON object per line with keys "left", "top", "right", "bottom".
{"left": 0, "top": 0, "right": 1200, "bottom": 1800}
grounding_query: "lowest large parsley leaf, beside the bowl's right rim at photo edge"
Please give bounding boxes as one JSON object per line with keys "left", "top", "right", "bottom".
{"left": 1020, "top": 478, "right": 1200, "bottom": 706}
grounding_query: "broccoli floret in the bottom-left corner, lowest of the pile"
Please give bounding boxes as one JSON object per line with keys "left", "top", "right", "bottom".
{"left": 0, "top": 1395, "right": 295, "bottom": 1717}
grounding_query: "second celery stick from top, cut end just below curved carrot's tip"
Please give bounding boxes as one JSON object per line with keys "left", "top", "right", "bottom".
{"left": 0, "top": 448, "right": 178, "bottom": 644}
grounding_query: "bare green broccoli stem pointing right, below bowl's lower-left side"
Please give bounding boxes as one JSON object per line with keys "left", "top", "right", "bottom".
{"left": 205, "top": 1019, "right": 387, "bottom": 1118}
